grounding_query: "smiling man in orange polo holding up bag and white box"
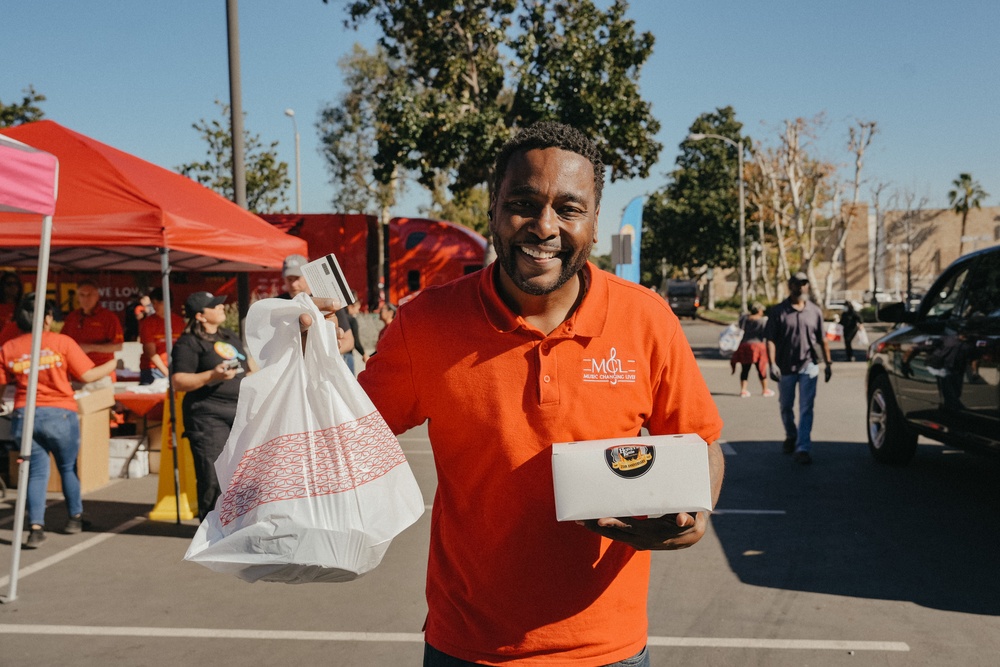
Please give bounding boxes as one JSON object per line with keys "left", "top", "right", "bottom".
{"left": 359, "top": 123, "right": 724, "bottom": 667}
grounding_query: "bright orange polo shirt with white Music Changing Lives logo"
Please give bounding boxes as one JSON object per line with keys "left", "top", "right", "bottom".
{"left": 358, "top": 264, "right": 722, "bottom": 667}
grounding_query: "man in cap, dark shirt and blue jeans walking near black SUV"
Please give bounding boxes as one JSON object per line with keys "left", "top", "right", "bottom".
{"left": 764, "top": 271, "right": 833, "bottom": 465}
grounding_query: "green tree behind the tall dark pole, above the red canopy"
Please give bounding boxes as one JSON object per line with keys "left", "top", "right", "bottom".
{"left": 177, "top": 100, "right": 292, "bottom": 213}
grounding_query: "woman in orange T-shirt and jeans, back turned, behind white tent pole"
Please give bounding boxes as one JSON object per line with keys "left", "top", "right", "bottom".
{"left": 0, "top": 294, "right": 116, "bottom": 548}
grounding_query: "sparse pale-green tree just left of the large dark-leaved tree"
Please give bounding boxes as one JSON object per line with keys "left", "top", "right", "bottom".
{"left": 316, "top": 44, "right": 402, "bottom": 214}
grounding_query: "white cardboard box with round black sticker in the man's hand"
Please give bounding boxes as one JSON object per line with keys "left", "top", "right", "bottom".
{"left": 552, "top": 433, "right": 712, "bottom": 521}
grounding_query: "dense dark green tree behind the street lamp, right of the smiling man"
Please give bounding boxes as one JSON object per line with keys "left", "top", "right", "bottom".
{"left": 642, "top": 107, "right": 750, "bottom": 282}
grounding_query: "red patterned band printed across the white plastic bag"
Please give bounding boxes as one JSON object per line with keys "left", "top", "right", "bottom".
{"left": 219, "top": 412, "right": 406, "bottom": 525}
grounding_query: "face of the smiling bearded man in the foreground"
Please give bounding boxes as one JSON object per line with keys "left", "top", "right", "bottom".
{"left": 490, "top": 148, "right": 600, "bottom": 296}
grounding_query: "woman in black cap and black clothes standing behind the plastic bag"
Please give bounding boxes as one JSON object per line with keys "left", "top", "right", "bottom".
{"left": 170, "top": 292, "right": 249, "bottom": 520}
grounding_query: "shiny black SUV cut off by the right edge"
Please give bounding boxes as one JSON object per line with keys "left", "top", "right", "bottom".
{"left": 867, "top": 246, "right": 1000, "bottom": 464}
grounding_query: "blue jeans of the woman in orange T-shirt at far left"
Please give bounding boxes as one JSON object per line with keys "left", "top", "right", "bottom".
{"left": 10, "top": 408, "right": 83, "bottom": 526}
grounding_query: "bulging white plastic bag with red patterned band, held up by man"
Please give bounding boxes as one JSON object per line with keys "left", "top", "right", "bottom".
{"left": 184, "top": 295, "right": 424, "bottom": 583}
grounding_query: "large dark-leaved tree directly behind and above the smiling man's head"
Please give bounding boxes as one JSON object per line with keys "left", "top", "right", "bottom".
{"left": 345, "top": 0, "right": 661, "bottom": 201}
